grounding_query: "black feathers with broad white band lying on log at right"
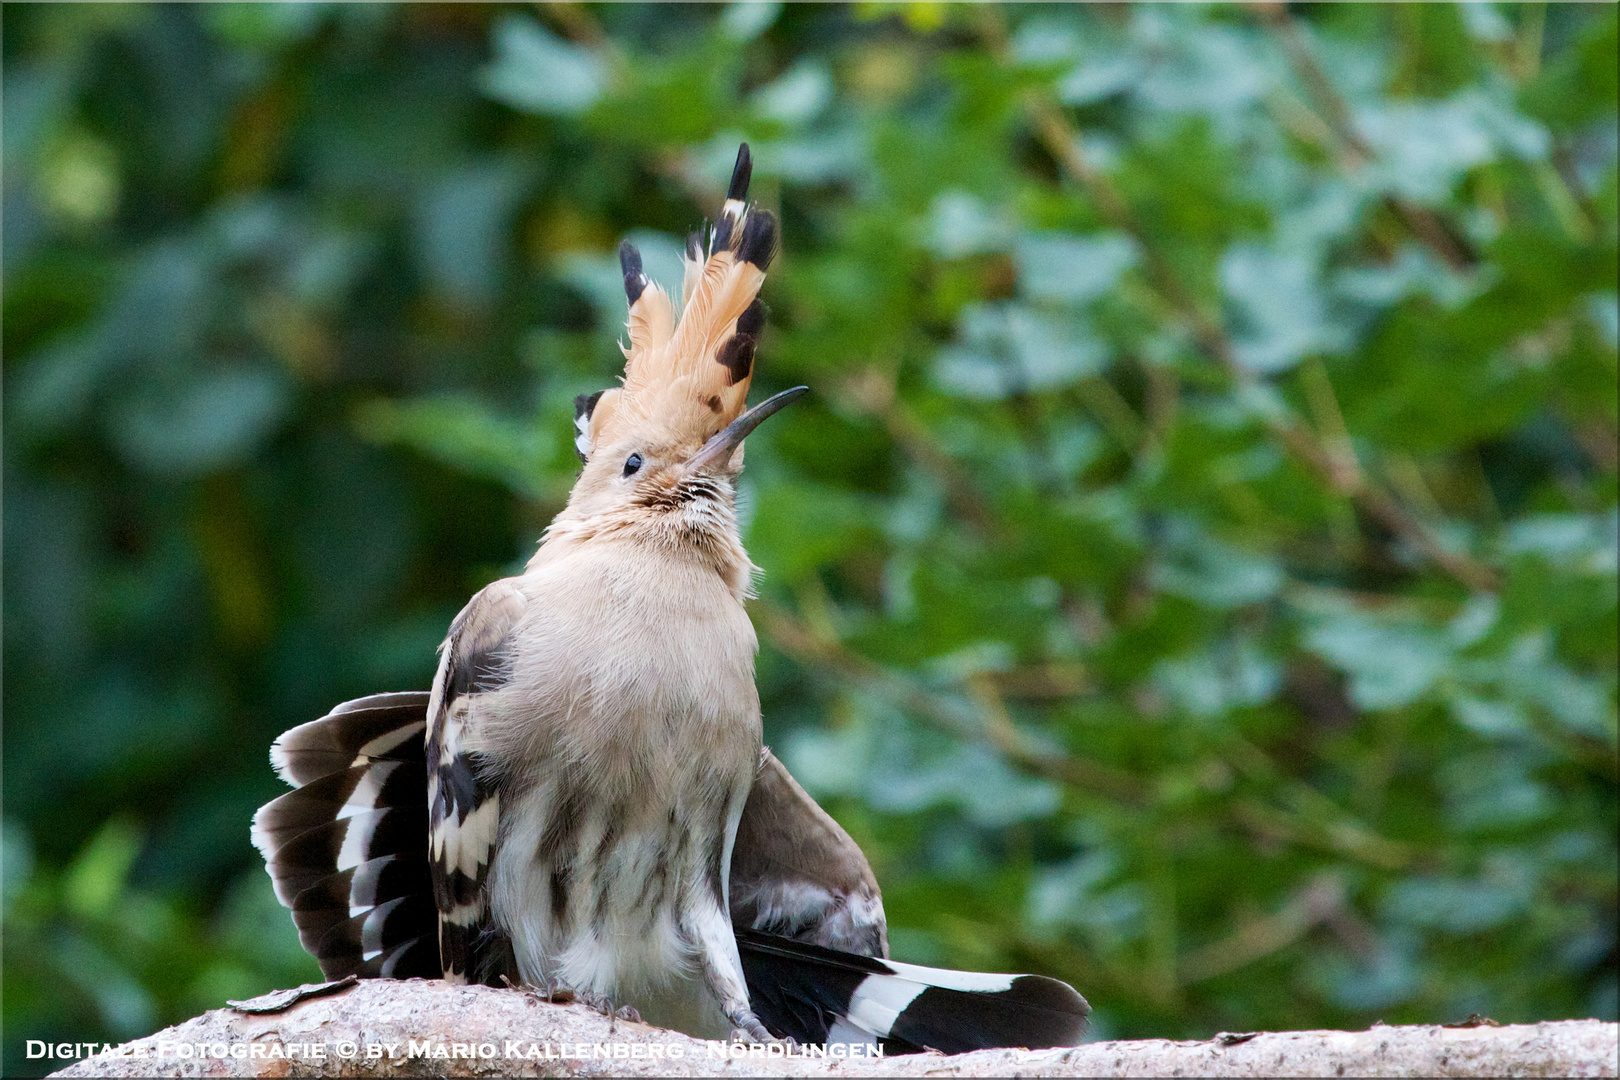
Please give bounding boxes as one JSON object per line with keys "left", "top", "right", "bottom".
{"left": 737, "top": 929, "right": 1090, "bottom": 1054}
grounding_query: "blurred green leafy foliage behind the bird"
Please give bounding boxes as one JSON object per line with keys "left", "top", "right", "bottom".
{"left": 3, "top": 3, "right": 1617, "bottom": 1075}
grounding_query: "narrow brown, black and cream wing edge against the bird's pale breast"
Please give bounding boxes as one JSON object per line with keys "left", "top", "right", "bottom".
{"left": 428, "top": 581, "right": 525, "bottom": 984}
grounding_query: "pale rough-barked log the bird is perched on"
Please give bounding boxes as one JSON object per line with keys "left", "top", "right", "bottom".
{"left": 52, "top": 980, "right": 1620, "bottom": 1077}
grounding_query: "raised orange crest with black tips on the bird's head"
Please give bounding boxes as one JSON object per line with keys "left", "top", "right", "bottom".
{"left": 575, "top": 142, "right": 776, "bottom": 458}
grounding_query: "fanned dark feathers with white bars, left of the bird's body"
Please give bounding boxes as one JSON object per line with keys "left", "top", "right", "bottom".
{"left": 253, "top": 693, "right": 441, "bottom": 978}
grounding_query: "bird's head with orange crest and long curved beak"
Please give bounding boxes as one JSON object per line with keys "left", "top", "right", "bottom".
{"left": 549, "top": 144, "right": 807, "bottom": 570}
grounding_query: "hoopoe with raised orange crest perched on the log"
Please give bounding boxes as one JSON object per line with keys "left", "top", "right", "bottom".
{"left": 251, "top": 144, "right": 1090, "bottom": 1052}
